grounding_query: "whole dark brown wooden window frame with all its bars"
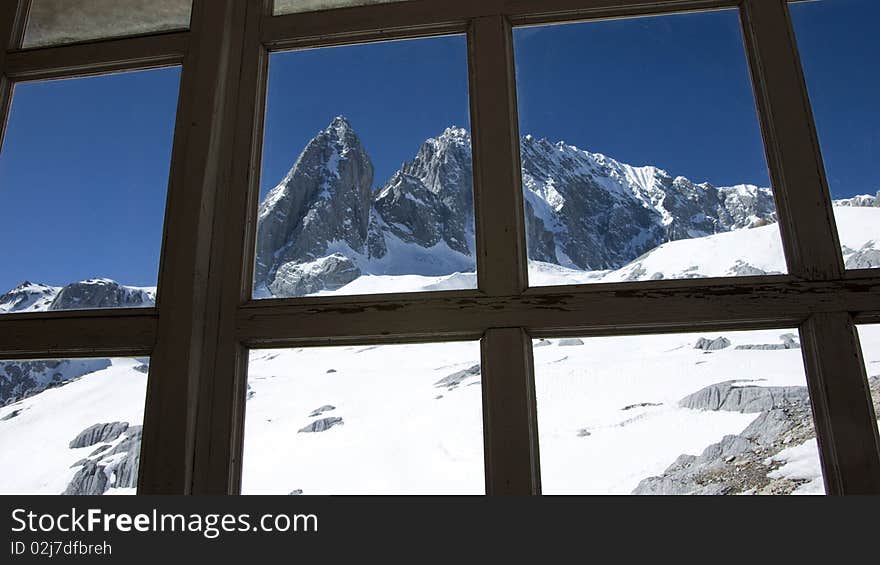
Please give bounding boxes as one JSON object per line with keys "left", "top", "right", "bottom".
{"left": 0, "top": 0, "right": 880, "bottom": 495}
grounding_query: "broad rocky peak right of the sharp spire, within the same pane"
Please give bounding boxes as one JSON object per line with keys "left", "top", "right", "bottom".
{"left": 374, "top": 128, "right": 474, "bottom": 257}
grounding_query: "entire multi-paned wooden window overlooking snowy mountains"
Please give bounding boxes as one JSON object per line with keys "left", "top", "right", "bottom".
{"left": 0, "top": 0, "right": 880, "bottom": 495}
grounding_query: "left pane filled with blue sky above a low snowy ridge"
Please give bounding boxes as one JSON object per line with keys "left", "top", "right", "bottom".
{"left": 0, "top": 68, "right": 180, "bottom": 313}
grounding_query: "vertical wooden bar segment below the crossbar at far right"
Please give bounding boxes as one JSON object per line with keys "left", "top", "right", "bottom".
{"left": 801, "top": 312, "right": 880, "bottom": 494}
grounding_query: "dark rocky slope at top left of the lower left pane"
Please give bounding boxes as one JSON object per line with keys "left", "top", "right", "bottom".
{"left": 0, "top": 359, "right": 110, "bottom": 406}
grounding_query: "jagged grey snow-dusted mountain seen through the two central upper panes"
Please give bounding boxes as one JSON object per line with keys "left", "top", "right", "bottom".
{"left": 255, "top": 117, "right": 775, "bottom": 296}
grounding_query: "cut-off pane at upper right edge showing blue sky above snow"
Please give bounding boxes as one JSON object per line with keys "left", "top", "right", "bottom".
{"left": 790, "top": 0, "right": 880, "bottom": 269}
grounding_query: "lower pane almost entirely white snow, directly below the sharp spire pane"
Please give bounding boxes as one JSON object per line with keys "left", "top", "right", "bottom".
{"left": 242, "top": 342, "right": 485, "bottom": 495}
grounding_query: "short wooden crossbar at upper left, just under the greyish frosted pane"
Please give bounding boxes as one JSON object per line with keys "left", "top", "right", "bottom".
{"left": 6, "top": 31, "right": 190, "bottom": 80}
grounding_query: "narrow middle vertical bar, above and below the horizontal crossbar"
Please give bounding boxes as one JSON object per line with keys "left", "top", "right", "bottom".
{"left": 468, "top": 16, "right": 541, "bottom": 495}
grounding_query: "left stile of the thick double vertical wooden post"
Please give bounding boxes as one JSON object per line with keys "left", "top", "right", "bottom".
{"left": 138, "top": 0, "right": 248, "bottom": 494}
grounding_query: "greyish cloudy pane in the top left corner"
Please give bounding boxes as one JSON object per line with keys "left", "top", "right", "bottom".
{"left": 23, "top": 0, "right": 192, "bottom": 47}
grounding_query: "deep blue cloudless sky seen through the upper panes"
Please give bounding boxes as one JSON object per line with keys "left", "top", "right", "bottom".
{"left": 0, "top": 0, "right": 880, "bottom": 296}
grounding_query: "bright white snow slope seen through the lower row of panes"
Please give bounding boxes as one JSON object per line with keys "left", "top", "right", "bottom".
{"left": 0, "top": 326, "right": 880, "bottom": 494}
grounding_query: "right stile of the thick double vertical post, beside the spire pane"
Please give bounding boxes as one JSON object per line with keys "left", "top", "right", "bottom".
{"left": 193, "top": 0, "right": 270, "bottom": 494}
